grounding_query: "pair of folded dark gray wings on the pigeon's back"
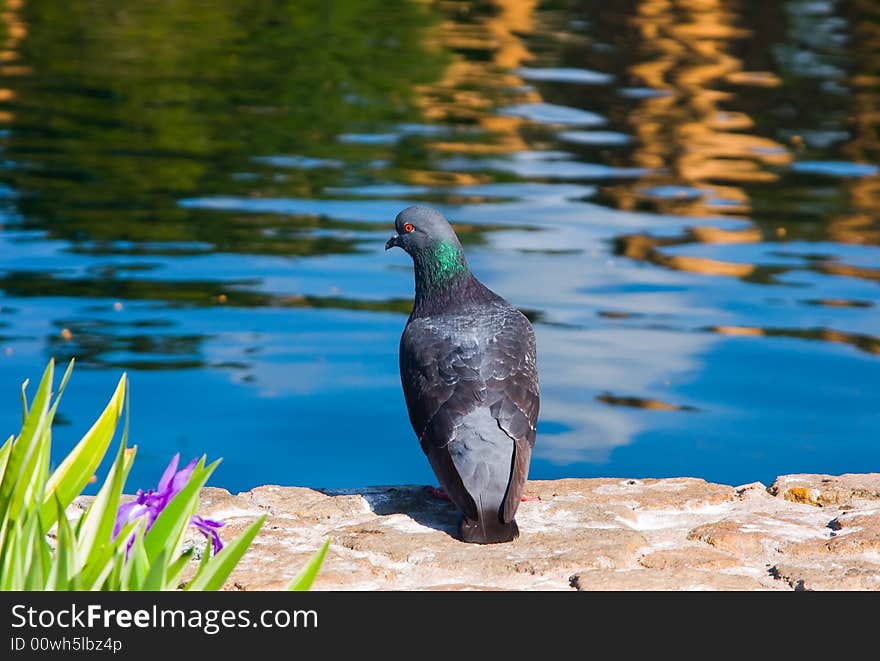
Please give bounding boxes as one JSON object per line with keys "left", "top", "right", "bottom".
{"left": 400, "top": 308, "right": 538, "bottom": 521}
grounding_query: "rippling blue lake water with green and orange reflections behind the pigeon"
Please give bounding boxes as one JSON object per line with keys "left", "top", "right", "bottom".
{"left": 0, "top": 0, "right": 880, "bottom": 491}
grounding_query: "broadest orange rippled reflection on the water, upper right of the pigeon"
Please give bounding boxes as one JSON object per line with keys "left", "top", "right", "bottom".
{"left": 610, "top": 0, "right": 792, "bottom": 215}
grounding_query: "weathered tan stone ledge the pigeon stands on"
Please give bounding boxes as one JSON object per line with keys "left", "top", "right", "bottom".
{"left": 174, "top": 474, "right": 880, "bottom": 590}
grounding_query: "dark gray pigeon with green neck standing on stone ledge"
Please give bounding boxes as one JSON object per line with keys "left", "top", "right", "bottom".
{"left": 385, "top": 206, "right": 540, "bottom": 544}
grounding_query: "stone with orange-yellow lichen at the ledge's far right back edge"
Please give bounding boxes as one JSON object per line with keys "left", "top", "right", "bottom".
{"left": 768, "top": 473, "right": 880, "bottom": 507}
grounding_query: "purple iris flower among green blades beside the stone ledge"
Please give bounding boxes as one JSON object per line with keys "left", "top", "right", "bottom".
{"left": 113, "top": 453, "right": 224, "bottom": 555}
